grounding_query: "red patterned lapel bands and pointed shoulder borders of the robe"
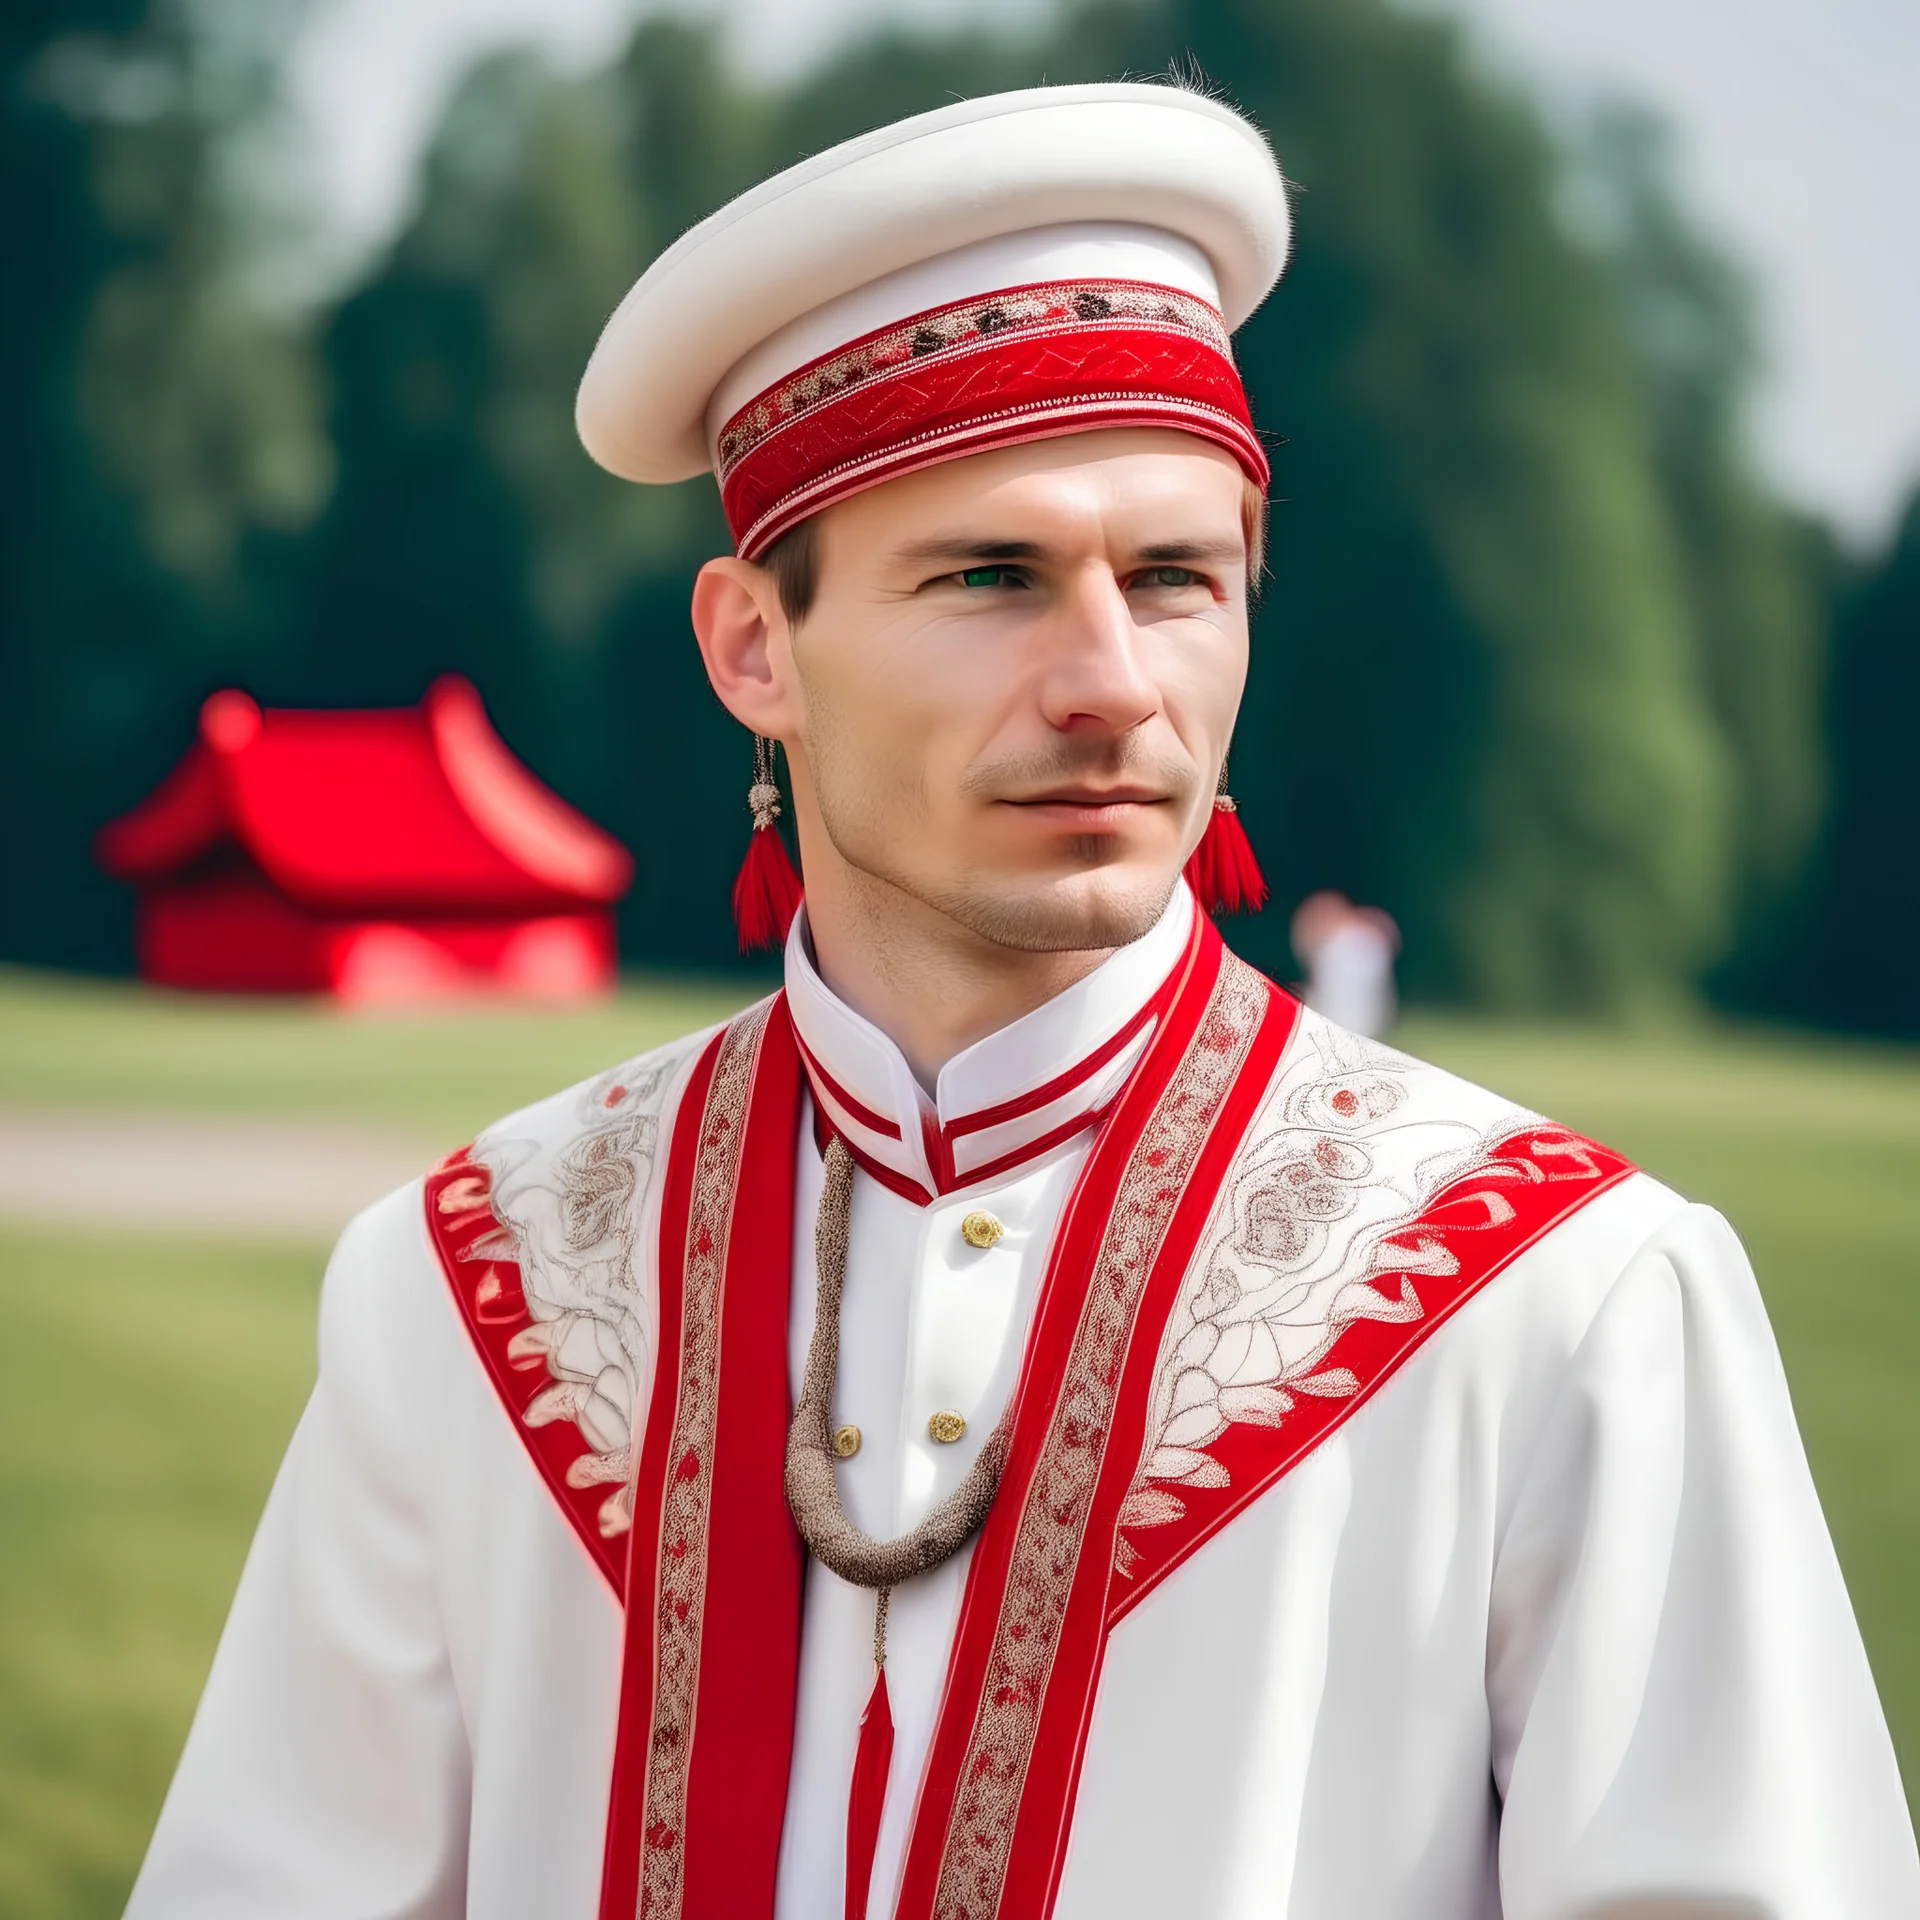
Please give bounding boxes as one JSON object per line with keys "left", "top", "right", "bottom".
{"left": 428, "top": 918, "right": 1632, "bottom": 1920}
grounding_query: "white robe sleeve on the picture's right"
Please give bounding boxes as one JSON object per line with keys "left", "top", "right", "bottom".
{"left": 1488, "top": 1206, "right": 1920, "bottom": 1920}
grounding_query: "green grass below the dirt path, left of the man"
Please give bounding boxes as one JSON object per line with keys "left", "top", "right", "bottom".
{"left": 0, "top": 1231, "right": 324, "bottom": 1920}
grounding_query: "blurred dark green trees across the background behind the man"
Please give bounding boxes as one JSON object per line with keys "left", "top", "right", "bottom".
{"left": 0, "top": 0, "right": 1920, "bottom": 1033}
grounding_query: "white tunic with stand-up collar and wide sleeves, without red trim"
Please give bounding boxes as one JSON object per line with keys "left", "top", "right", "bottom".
{"left": 129, "top": 893, "right": 1920, "bottom": 1920}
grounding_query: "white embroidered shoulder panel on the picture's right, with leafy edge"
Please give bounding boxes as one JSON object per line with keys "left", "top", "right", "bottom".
{"left": 1119, "top": 1010, "right": 1538, "bottom": 1569}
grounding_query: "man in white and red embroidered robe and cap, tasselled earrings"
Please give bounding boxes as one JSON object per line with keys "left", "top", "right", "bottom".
{"left": 132, "top": 86, "right": 1920, "bottom": 1920}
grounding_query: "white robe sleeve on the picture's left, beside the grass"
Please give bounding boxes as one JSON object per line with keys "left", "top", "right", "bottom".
{"left": 127, "top": 1187, "right": 468, "bottom": 1920}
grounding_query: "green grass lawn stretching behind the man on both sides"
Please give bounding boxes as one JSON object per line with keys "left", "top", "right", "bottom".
{"left": 0, "top": 973, "right": 1920, "bottom": 1920}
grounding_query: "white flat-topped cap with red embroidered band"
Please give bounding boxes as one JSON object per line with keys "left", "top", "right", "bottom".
{"left": 576, "top": 83, "right": 1288, "bottom": 549}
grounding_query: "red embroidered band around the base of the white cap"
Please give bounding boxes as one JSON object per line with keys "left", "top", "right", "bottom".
{"left": 716, "top": 280, "right": 1267, "bottom": 561}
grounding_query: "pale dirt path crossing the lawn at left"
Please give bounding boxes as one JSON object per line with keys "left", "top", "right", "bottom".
{"left": 0, "top": 1108, "right": 436, "bottom": 1240}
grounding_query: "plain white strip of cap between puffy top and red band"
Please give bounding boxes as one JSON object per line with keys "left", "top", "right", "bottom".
{"left": 707, "top": 221, "right": 1219, "bottom": 449}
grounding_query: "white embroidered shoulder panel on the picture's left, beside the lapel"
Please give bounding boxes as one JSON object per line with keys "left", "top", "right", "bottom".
{"left": 472, "top": 1029, "right": 712, "bottom": 1536}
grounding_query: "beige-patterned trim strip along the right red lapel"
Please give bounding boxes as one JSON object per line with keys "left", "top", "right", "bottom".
{"left": 933, "top": 954, "right": 1269, "bottom": 1920}
